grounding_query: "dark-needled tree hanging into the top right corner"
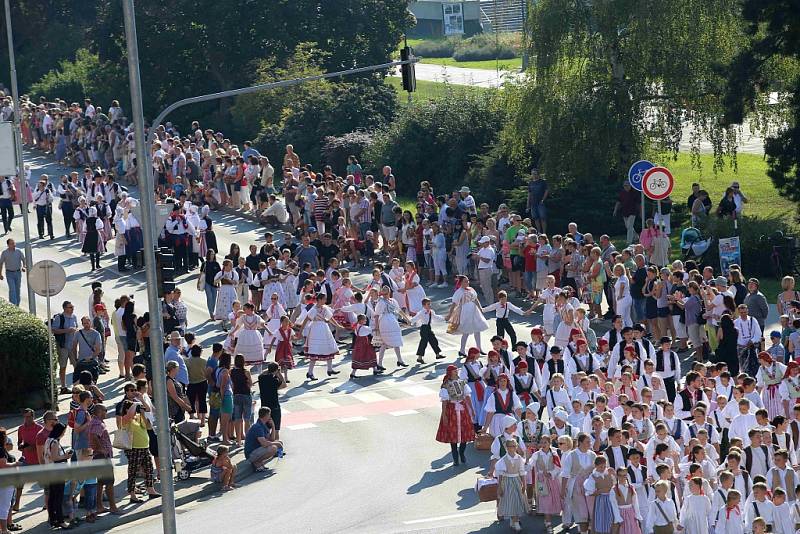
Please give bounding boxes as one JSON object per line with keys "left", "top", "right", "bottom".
{"left": 725, "top": 0, "right": 800, "bottom": 216}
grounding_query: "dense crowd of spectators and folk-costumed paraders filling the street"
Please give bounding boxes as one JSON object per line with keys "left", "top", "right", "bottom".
{"left": 0, "top": 93, "right": 800, "bottom": 534}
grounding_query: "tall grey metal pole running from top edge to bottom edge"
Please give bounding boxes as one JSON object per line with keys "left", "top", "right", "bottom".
{"left": 120, "top": 0, "right": 176, "bottom": 534}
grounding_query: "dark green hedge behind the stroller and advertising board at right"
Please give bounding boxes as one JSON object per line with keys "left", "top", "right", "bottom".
{"left": 700, "top": 215, "right": 791, "bottom": 277}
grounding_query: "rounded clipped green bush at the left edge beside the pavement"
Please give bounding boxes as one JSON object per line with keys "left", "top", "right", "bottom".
{"left": 0, "top": 300, "right": 57, "bottom": 412}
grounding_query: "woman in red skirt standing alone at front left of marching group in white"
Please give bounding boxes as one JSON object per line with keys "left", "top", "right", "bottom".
{"left": 436, "top": 365, "right": 475, "bottom": 466}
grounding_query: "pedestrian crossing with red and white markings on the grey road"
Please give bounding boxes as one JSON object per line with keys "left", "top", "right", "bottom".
{"left": 281, "top": 377, "right": 440, "bottom": 431}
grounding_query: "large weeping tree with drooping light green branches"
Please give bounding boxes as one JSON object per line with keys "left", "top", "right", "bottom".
{"left": 504, "top": 0, "right": 743, "bottom": 190}
